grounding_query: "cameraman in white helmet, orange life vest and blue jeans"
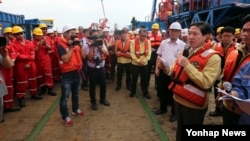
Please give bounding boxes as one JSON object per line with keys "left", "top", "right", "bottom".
{"left": 57, "top": 25, "right": 85, "bottom": 126}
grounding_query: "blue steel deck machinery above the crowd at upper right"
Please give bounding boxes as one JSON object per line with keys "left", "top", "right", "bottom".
{"left": 130, "top": 0, "right": 250, "bottom": 30}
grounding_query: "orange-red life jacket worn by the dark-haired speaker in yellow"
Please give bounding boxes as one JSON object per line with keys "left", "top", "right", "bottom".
{"left": 168, "top": 45, "right": 218, "bottom": 106}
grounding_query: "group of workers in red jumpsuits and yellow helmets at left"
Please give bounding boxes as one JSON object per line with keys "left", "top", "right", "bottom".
{"left": 1, "top": 24, "right": 60, "bottom": 113}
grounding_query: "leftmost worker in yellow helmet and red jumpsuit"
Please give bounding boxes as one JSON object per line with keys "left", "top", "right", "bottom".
{"left": 0, "top": 27, "right": 21, "bottom": 113}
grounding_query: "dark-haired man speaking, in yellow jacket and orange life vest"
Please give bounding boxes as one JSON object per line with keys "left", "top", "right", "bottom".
{"left": 165, "top": 22, "right": 221, "bottom": 141}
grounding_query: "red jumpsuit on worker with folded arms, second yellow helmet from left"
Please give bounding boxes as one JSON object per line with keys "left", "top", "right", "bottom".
{"left": 13, "top": 40, "right": 37, "bottom": 99}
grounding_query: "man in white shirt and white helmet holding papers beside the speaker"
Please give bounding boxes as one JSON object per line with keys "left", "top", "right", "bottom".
{"left": 155, "top": 22, "right": 186, "bottom": 122}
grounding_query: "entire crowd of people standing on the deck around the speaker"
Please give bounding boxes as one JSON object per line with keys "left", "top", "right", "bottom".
{"left": 0, "top": 15, "right": 250, "bottom": 141}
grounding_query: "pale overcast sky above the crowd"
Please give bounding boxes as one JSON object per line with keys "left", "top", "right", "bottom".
{"left": 0, "top": 0, "right": 153, "bottom": 29}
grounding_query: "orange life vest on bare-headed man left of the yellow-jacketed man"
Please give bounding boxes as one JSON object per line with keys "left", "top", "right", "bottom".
{"left": 116, "top": 39, "right": 131, "bottom": 59}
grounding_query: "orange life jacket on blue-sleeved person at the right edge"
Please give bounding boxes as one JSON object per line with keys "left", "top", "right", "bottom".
{"left": 223, "top": 45, "right": 250, "bottom": 115}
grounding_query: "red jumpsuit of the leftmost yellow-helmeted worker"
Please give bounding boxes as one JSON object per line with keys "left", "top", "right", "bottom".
{"left": 1, "top": 44, "right": 16, "bottom": 109}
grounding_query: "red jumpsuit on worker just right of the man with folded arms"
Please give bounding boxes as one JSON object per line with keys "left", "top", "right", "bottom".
{"left": 33, "top": 40, "right": 54, "bottom": 88}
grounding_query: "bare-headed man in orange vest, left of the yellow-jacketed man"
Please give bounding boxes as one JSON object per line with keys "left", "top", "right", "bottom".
{"left": 115, "top": 30, "right": 131, "bottom": 91}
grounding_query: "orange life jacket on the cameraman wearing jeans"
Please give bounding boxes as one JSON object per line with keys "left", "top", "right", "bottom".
{"left": 59, "top": 37, "right": 82, "bottom": 73}
